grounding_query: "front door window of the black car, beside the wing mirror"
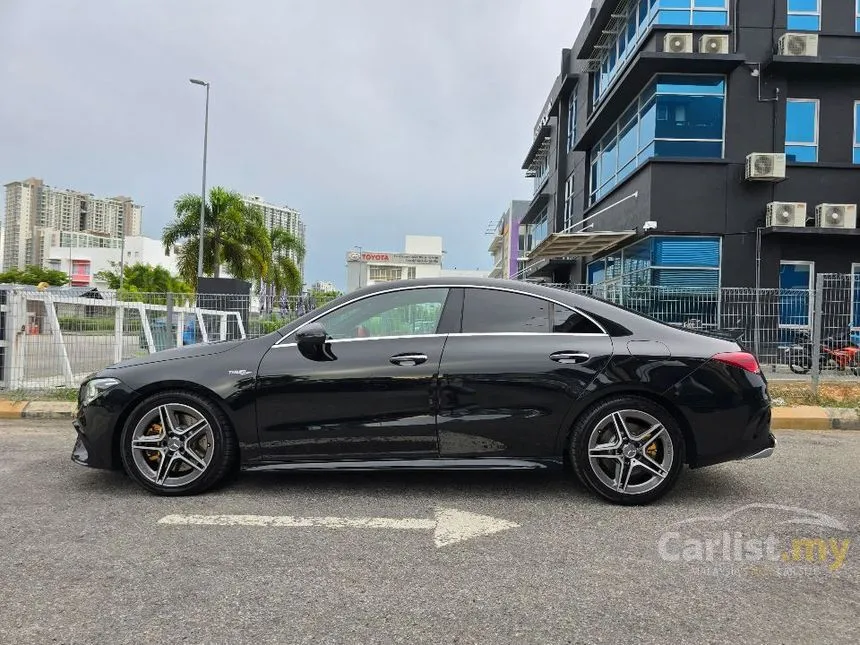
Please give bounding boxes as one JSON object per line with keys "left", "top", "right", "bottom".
{"left": 317, "top": 288, "right": 448, "bottom": 340}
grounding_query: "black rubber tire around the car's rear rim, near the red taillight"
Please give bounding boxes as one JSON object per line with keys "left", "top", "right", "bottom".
{"left": 569, "top": 395, "right": 686, "bottom": 506}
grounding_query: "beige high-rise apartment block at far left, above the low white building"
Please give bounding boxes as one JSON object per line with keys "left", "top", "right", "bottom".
{"left": 2, "top": 177, "right": 143, "bottom": 269}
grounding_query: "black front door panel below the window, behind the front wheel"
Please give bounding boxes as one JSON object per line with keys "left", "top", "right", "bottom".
{"left": 257, "top": 335, "right": 445, "bottom": 460}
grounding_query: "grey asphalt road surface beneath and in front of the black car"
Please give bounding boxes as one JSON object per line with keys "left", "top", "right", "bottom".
{"left": 0, "top": 421, "right": 860, "bottom": 644}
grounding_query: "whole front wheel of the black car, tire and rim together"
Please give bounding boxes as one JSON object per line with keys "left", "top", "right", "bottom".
{"left": 120, "top": 391, "right": 238, "bottom": 495}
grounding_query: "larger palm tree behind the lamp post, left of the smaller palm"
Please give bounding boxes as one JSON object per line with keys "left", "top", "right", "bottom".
{"left": 161, "top": 186, "right": 272, "bottom": 285}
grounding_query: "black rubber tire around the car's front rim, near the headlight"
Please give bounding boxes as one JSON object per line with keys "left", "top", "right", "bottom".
{"left": 120, "top": 391, "right": 239, "bottom": 496}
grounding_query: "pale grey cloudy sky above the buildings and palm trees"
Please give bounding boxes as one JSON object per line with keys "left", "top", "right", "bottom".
{"left": 0, "top": 0, "right": 590, "bottom": 285}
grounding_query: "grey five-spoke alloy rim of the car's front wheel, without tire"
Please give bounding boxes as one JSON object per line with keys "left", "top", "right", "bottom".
{"left": 131, "top": 403, "right": 215, "bottom": 488}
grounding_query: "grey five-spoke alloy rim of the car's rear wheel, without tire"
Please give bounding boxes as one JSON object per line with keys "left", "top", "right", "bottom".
{"left": 588, "top": 410, "right": 675, "bottom": 495}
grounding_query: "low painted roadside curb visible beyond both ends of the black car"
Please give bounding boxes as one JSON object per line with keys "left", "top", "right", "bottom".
{"left": 0, "top": 400, "right": 860, "bottom": 431}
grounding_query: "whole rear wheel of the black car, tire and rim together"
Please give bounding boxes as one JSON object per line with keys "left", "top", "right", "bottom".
{"left": 570, "top": 396, "right": 685, "bottom": 505}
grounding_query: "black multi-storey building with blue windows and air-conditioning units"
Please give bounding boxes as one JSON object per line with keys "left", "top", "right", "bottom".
{"left": 522, "top": 0, "right": 860, "bottom": 310}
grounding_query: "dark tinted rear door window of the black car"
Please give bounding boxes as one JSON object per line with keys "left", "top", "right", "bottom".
{"left": 463, "top": 289, "right": 550, "bottom": 334}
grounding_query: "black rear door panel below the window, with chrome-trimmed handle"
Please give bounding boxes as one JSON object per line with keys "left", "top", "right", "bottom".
{"left": 437, "top": 334, "right": 612, "bottom": 458}
